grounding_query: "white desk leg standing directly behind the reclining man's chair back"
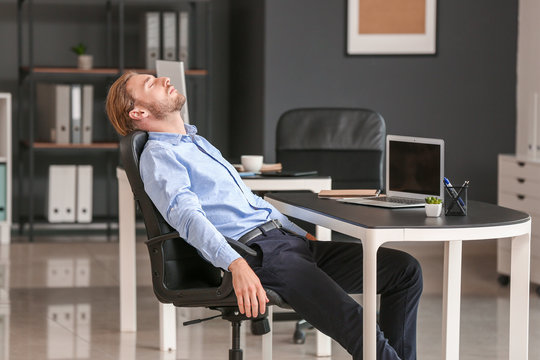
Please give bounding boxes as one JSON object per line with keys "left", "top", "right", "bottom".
{"left": 118, "top": 178, "right": 137, "bottom": 332}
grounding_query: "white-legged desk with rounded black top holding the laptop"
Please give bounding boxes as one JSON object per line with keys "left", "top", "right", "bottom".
{"left": 266, "top": 193, "right": 531, "bottom": 360}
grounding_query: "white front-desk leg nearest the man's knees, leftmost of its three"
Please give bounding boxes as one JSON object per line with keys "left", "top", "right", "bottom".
{"left": 362, "top": 238, "right": 379, "bottom": 359}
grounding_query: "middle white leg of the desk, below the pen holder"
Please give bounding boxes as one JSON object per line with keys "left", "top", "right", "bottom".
{"left": 442, "top": 240, "right": 462, "bottom": 360}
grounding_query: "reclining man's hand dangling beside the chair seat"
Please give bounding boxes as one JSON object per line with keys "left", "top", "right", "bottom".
{"left": 229, "top": 258, "right": 270, "bottom": 317}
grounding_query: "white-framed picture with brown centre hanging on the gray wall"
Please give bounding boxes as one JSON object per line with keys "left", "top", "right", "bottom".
{"left": 347, "top": 0, "right": 437, "bottom": 55}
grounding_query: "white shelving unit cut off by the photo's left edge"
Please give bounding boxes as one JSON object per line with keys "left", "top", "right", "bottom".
{"left": 0, "top": 93, "right": 11, "bottom": 244}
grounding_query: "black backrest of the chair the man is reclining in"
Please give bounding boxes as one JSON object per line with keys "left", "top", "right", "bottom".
{"left": 120, "top": 131, "right": 221, "bottom": 294}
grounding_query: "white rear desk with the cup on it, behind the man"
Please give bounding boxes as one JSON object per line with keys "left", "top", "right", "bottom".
{"left": 116, "top": 168, "right": 332, "bottom": 356}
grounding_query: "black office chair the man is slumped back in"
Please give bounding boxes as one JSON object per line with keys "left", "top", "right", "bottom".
{"left": 120, "top": 131, "right": 287, "bottom": 360}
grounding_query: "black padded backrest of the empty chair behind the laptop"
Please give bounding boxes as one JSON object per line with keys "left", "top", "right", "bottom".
{"left": 276, "top": 108, "right": 386, "bottom": 189}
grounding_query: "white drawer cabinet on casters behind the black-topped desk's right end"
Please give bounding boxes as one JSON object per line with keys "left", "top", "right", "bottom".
{"left": 497, "top": 155, "right": 540, "bottom": 284}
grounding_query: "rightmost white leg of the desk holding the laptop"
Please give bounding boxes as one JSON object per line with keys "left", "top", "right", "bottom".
{"left": 509, "top": 234, "right": 531, "bottom": 360}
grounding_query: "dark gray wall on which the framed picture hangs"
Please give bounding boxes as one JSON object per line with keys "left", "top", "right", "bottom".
{"left": 232, "top": 0, "right": 517, "bottom": 202}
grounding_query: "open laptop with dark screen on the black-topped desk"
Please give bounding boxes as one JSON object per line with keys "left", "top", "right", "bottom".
{"left": 338, "top": 135, "right": 444, "bottom": 208}
